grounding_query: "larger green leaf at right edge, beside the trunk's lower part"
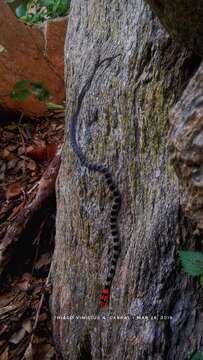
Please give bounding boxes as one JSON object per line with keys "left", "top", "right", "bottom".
{"left": 179, "top": 251, "right": 203, "bottom": 276}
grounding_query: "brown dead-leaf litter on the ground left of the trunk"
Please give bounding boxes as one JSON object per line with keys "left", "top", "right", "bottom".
{"left": 0, "top": 114, "right": 64, "bottom": 360}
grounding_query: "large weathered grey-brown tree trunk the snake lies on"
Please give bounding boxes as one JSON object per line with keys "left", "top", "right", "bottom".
{"left": 52, "top": 0, "right": 202, "bottom": 360}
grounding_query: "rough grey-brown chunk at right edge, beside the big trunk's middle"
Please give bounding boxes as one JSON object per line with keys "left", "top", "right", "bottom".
{"left": 169, "top": 65, "right": 203, "bottom": 231}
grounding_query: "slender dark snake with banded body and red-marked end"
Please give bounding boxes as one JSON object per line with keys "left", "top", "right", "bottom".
{"left": 69, "top": 55, "right": 121, "bottom": 307}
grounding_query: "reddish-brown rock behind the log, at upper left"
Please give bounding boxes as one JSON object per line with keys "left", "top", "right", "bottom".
{"left": 0, "top": 1, "right": 67, "bottom": 116}
